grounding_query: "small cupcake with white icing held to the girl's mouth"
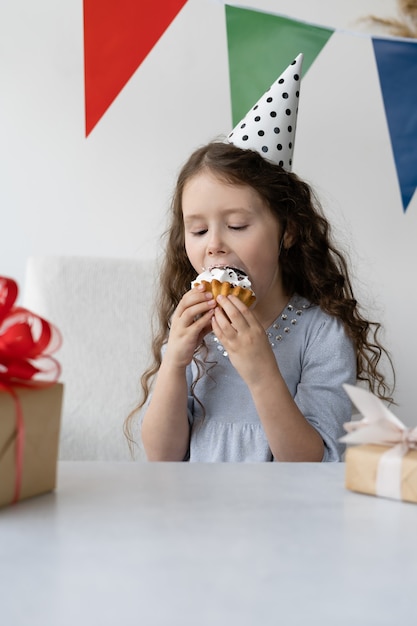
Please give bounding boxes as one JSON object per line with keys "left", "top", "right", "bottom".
{"left": 191, "top": 266, "right": 256, "bottom": 307}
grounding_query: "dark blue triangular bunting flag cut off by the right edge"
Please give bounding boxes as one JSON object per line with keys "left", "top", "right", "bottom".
{"left": 372, "top": 38, "right": 417, "bottom": 212}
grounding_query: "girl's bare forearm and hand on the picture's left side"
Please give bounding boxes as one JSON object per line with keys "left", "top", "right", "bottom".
{"left": 142, "top": 286, "right": 216, "bottom": 461}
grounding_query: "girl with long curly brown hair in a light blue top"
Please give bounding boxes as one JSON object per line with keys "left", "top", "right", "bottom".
{"left": 127, "top": 56, "right": 389, "bottom": 462}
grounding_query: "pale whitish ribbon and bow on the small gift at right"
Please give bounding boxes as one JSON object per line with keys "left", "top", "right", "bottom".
{"left": 340, "top": 385, "right": 417, "bottom": 500}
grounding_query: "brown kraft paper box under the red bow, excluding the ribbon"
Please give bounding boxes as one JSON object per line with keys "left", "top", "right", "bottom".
{"left": 0, "top": 383, "right": 63, "bottom": 506}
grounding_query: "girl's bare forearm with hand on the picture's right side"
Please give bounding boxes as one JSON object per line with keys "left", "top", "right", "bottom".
{"left": 212, "top": 296, "right": 324, "bottom": 461}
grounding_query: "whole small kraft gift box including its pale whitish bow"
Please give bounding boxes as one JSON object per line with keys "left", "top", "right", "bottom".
{"left": 341, "top": 385, "right": 417, "bottom": 503}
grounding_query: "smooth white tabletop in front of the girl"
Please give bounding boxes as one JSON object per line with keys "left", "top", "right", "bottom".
{"left": 0, "top": 462, "right": 417, "bottom": 626}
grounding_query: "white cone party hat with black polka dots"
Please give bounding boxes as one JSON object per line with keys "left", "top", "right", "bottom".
{"left": 227, "top": 53, "right": 303, "bottom": 171}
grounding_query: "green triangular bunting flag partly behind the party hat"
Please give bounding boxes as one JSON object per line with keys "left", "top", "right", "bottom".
{"left": 225, "top": 5, "right": 334, "bottom": 126}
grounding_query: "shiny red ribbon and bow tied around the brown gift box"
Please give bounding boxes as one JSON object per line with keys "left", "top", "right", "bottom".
{"left": 0, "top": 276, "right": 62, "bottom": 502}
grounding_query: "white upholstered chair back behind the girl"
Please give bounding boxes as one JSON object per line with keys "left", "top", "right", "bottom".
{"left": 22, "top": 256, "right": 156, "bottom": 461}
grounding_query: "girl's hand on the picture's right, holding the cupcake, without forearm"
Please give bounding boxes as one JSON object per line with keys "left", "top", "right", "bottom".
{"left": 212, "top": 296, "right": 277, "bottom": 387}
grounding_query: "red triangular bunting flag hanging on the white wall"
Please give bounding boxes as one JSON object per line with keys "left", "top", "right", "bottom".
{"left": 84, "top": 0, "right": 187, "bottom": 136}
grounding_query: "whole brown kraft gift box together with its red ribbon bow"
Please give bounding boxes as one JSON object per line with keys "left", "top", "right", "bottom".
{"left": 0, "top": 276, "right": 63, "bottom": 506}
